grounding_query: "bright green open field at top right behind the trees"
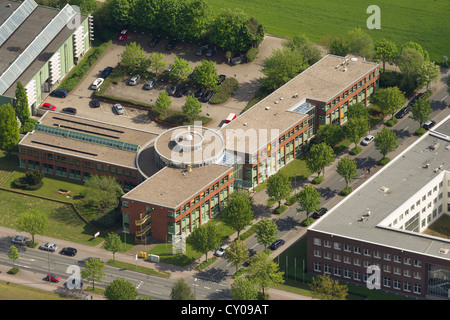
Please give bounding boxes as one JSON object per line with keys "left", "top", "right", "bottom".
{"left": 208, "top": 0, "right": 450, "bottom": 61}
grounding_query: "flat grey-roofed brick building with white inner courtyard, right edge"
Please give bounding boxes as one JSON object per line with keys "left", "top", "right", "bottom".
{"left": 307, "top": 116, "right": 450, "bottom": 299}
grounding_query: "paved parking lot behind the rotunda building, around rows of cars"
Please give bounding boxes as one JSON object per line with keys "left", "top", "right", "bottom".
{"left": 45, "top": 34, "right": 283, "bottom": 133}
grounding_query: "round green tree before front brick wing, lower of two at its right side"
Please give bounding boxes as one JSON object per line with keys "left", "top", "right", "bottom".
{"left": 188, "top": 222, "right": 222, "bottom": 260}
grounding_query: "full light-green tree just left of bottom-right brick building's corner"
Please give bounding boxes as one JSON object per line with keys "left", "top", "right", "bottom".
{"left": 247, "top": 251, "right": 284, "bottom": 296}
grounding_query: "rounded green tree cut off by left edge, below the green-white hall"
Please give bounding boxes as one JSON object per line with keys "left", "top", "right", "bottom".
{"left": 0, "top": 103, "right": 20, "bottom": 156}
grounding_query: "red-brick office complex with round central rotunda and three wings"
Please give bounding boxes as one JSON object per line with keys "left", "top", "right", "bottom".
{"left": 19, "top": 55, "right": 379, "bottom": 243}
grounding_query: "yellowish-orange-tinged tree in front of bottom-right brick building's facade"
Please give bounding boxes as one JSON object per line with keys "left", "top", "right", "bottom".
{"left": 309, "top": 274, "right": 348, "bottom": 300}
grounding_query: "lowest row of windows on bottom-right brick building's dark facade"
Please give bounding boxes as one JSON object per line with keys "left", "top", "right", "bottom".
{"left": 314, "top": 262, "right": 422, "bottom": 295}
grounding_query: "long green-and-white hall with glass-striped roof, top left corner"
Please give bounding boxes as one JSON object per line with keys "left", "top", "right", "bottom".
{"left": 0, "top": 0, "right": 92, "bottom": 114}
